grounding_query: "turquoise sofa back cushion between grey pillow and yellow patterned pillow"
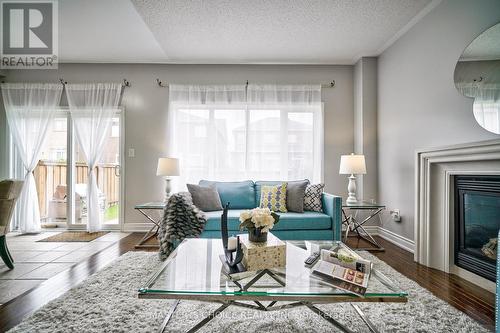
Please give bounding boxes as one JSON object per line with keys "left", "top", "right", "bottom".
{"left": 199, "top": 180, "right": 257, "bottom": 209}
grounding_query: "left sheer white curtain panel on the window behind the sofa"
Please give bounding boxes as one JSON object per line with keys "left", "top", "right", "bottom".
{"left": 168, "top": 84, "right": 246, "bottom": 189}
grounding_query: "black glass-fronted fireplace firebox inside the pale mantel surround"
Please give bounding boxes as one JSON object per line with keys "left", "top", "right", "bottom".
{"left": 455, "top": 175, "right": 500, "bottom": 281}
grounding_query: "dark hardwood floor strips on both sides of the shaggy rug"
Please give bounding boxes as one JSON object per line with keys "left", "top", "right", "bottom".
{"left": 0, "top": 233, "right": 495, "bottom": 332}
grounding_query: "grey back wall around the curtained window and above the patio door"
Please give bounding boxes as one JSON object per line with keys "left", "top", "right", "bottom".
{"left": 0, "top": 64, "right": 353, "bottom": 227}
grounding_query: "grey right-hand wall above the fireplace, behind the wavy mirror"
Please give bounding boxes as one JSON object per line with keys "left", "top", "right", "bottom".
{"left": 378, "top": 0, "right": 500, "bottom": 239}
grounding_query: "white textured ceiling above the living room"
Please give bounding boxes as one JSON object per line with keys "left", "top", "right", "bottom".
{"left": 59, "top": 0, "right": 440, "bottom": 64}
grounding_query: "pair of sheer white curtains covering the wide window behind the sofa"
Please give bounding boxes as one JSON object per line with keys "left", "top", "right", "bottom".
{"left": 169, "top": 85, "right": 323, "bottom": 186}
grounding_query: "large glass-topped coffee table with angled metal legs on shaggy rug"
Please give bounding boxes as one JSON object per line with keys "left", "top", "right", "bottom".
{"left": 138, "top": 238, "right": 408, "bottom": 332}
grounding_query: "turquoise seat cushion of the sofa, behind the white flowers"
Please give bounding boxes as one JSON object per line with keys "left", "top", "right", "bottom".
{"left": 205, "top": 209, "right": 332, "bottom": 233}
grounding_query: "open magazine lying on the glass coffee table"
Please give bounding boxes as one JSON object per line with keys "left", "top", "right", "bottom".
{"left": 311, "top": 244, "right": 372, "bottom": 296}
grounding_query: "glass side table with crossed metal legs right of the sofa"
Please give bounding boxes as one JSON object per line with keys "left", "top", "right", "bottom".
{"left": 342, "top": 201, "right": 385, "bottom": 251}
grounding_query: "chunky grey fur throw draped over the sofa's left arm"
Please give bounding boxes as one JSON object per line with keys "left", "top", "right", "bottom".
{"left": 158, "top": 192, "right": 207, "bottom": 260}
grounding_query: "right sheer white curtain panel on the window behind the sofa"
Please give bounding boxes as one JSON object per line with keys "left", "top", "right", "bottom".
{"left": 247, "top": 84, "right": 324, "bottom": 182}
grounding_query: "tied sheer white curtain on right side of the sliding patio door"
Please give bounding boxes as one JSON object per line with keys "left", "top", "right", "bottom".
{"left": 66, "top": 83, "right": 122, "bottom": 232}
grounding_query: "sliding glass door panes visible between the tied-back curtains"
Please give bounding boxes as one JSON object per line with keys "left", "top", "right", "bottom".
{"left": 9, "top": 109, "right": 123, "bottom": 230}
